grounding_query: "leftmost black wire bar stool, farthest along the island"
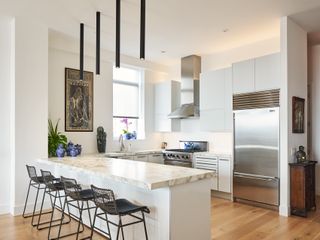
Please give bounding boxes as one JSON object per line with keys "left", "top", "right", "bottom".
{"left": 22, "top": 165, "right": 60, "bottom": 230}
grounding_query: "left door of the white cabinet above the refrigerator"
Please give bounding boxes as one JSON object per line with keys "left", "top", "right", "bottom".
{"left": 232, "top": 59, "right": 255, "bottom": 94}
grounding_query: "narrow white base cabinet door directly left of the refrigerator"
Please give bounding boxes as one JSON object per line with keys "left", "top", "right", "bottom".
{"left": 218, "top": 158, "right": 231, "bottom": 193}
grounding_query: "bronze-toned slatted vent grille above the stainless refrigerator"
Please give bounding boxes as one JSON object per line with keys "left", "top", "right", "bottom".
{"left": 233, "top": 89, "right": 280, "bottom": 110}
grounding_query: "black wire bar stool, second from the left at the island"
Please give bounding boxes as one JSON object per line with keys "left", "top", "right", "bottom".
{"left": 38, "top": 170, "right": 71, "bottom": 239}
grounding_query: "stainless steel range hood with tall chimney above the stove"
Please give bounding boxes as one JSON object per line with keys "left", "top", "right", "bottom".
{"left": 168, "top": 55, "right": 201, "bottom": 119}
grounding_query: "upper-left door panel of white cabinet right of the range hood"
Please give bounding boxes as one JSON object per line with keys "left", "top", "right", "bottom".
{"left": 200, "top": 69, "right": 225, "bottom": 110}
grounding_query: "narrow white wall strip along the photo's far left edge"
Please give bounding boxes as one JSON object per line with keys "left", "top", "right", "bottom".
{"left": 0, "top": 17, "right": 13, "bottom": 214}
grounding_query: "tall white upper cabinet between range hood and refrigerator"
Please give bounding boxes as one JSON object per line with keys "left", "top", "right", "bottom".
{"left": 200, "top": 68, "right": 232, "bottom": 132}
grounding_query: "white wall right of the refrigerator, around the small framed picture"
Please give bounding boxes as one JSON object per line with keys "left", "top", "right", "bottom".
{"left": 279, "top": 17, "right": 307, "bottom": 216}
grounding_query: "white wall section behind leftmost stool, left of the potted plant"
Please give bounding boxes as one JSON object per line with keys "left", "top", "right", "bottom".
{"left": 11, "top": 17, "right": 48, "bottom": 214}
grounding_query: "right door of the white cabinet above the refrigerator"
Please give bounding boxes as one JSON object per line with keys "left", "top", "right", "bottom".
{"left": 255, "top": 53, "right": 280, "bottom": 91}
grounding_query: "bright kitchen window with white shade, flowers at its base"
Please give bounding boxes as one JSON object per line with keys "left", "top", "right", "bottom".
{"left": 113, "top": 67, "right": 145, "bottom": 140}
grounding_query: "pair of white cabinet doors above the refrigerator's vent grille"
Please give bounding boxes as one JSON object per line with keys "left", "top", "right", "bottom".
{"left": 232, "top": 53, "right": 280, "bottom": 94}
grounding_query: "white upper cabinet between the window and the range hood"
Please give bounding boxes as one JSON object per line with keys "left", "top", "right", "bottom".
{"left": 154, "top": 81, "right": 180, "bottom": 132}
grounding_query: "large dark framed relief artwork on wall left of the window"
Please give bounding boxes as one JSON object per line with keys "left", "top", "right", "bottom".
{"left": 65, "top": 68, "right": 93, "bottom": 132}
